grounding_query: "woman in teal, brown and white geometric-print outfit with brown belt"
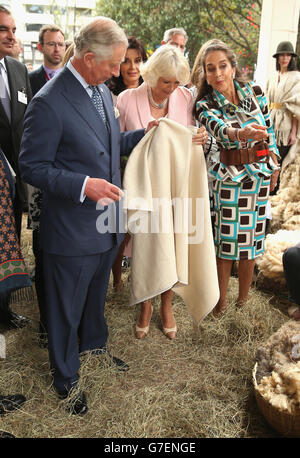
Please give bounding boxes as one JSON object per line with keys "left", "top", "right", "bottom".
{"left": 194, "top": 40, "right": 278, "bottom": 315}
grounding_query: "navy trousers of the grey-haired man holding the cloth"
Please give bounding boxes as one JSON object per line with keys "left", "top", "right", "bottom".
{"left": 44, "top": 245, "right": 118, "bottom": 392}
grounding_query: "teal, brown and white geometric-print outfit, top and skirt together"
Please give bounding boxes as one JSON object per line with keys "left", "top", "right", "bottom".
{"left": 196, "top": 80, "right": 279, "bottom": 260}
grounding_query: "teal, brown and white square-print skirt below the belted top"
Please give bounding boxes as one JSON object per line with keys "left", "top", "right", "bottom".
{"left": 213, "top": 177, "right": 270, "bottom": 260}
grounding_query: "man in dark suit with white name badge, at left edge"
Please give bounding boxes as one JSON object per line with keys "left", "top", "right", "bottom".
{"left": 0, "top": 5, "right": 31, "bottom": 327}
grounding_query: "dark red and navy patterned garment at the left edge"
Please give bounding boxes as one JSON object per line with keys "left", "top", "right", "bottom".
{"left": 0, "top": 151, "right": 31, "bottom": 295}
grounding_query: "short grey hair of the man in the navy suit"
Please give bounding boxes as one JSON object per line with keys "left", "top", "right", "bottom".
{"left": 74, "top": 16, "right": 128, "bottom": 61}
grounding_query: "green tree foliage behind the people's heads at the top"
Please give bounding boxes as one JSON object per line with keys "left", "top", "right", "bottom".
{"left": 96, "top": 0, "right": 262, "bottom": 69}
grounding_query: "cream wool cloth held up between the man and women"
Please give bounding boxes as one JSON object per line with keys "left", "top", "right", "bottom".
{"left": 123, "top": 118, "right": 219, "bottom": 324}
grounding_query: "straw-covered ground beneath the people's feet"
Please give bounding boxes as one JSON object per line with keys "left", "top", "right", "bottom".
{"left": 0, "top": 220, "right": 288, "bottom": 438}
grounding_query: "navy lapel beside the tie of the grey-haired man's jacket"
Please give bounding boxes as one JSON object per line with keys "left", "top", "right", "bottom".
{"left": 62, "top": 68, "right": 110, "bottom": 150}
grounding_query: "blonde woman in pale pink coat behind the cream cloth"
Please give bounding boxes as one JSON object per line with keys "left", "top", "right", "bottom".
{"left": 117, "top": 45, "right": 207, "bottom": 339}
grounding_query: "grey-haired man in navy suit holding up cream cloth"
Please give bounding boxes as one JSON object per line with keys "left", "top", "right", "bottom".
{"left": 19, "top": 18, "right": 157, "bottom": 414}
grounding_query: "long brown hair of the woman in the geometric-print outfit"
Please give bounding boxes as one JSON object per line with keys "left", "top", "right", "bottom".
{"left": 191, "top": 38, "right": 245, "bottom": 117}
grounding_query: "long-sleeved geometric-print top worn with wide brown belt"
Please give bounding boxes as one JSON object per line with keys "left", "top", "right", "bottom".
{"left": 197, "top": 80, "right": 279, "bottom": 183}
